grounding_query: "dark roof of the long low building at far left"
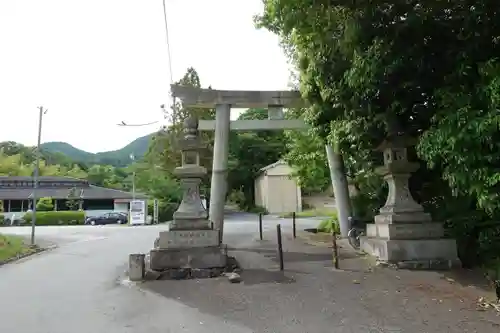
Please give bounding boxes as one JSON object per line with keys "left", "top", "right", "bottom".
{"left": 0, "top": 176, "right": 146, "bottom": 200}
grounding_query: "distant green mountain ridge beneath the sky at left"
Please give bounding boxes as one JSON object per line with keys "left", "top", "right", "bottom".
{"left": 40, "top": 133, "right": 155, "bottom": 167}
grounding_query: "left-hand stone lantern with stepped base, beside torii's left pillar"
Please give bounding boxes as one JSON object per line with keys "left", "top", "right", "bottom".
{"left": 150, "top": 116, "right": 227, "bottom": 277}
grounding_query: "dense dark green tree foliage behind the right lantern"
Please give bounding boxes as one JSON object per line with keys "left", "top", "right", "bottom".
{"left": 257, "top": 0, "right": 500, "bottom": 263}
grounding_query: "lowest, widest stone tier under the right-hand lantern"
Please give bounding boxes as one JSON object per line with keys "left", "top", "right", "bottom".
{"left": 361, "top": 237, "right": 460, "bottom": 269}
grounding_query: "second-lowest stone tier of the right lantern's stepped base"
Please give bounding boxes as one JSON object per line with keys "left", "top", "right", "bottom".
{"left": 366, "top": 222, "right": 444, "bottom": 239}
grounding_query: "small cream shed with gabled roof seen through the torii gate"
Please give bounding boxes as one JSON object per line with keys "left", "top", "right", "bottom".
{"left": 255, "top": 161, "right": 302, "bottom": 214}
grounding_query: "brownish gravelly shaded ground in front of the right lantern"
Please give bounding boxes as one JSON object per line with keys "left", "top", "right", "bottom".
{"left": 143, "top": 230, "right": 500, "bottom": 333}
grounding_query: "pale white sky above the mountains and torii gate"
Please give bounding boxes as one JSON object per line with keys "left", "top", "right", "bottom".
{"left": 0, "top": 0, "right": 290, "bottom": 152}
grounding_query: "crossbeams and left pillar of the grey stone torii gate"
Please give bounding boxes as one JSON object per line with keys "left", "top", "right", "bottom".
{"left": 171, "top": 85, "right": 316, "bottom": 242}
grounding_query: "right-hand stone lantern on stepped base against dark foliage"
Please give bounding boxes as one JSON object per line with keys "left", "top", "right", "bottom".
{"left": 361, "top": 135, "right": 459, "bottom": 269}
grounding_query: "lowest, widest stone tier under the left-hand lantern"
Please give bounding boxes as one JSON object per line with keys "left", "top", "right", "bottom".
{"left": 149, "top": 246, "right": 227, "bottom": 271}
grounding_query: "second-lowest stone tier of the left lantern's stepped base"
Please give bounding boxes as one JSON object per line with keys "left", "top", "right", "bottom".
{"left": 155, "top": 230, "right": 219, "bottom": 249}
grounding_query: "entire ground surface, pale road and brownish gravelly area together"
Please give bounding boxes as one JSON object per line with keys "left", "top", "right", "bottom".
{"left": 0, "top": 214, "right": 500, "bottom": 333}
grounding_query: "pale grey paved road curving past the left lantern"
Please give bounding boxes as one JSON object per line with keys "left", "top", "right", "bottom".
{"left": 0, "top": 215, "right": 317, "bottom": 333}
